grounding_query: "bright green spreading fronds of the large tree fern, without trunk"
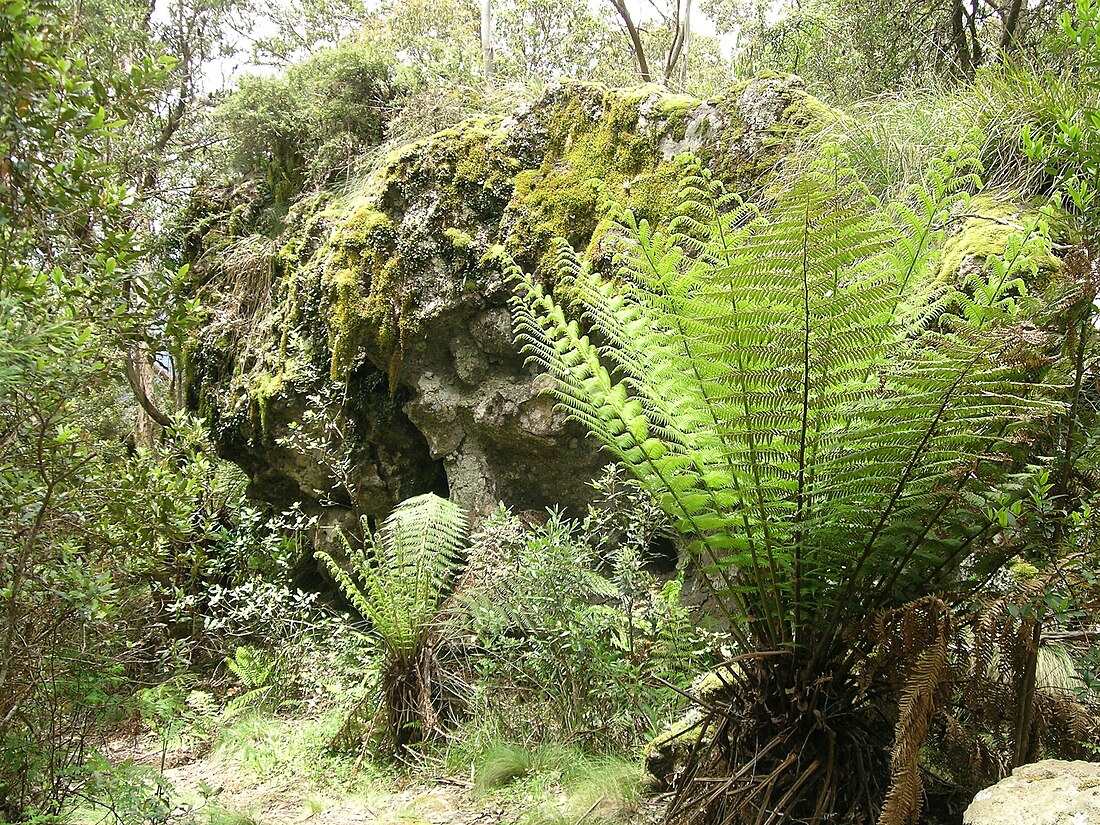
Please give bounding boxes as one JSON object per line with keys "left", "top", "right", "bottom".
{"left": 514, "top": 145, "right": 1056, "bottom": 646}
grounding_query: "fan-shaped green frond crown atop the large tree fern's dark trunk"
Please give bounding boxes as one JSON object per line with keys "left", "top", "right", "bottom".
{"left": 513, "top": 145, "right": 1054, "bottom": 645}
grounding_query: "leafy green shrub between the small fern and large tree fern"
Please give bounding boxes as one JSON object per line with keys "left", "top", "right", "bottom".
{"left": 455, "top": 495, "right": 700, "bottom": 751}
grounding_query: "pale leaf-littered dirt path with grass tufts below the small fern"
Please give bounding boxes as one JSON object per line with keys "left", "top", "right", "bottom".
{"left": 108, "top": 719, "right": 662, "bottom": 825}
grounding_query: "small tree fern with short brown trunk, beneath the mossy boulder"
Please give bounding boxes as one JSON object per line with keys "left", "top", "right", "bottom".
{"left": 317, "top": 493, "right": 466, "bottom": 747}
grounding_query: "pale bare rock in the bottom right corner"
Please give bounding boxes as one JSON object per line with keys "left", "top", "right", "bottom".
{"left": 963, "top": 759, "right": 1100, "bottom": 825}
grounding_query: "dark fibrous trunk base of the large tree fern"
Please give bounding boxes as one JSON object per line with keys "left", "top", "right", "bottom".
{"left": 667, "top": 653, "right": 890, "bottom": 825}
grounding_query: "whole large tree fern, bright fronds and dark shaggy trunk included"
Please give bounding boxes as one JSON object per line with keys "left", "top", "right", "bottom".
{"left": 513, "top": 153, "right": 1057, "bottom": 823}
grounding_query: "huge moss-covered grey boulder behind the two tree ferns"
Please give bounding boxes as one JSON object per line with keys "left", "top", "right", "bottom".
{"left": 184, "top": 75, "right": 832, "bottom": 530}
